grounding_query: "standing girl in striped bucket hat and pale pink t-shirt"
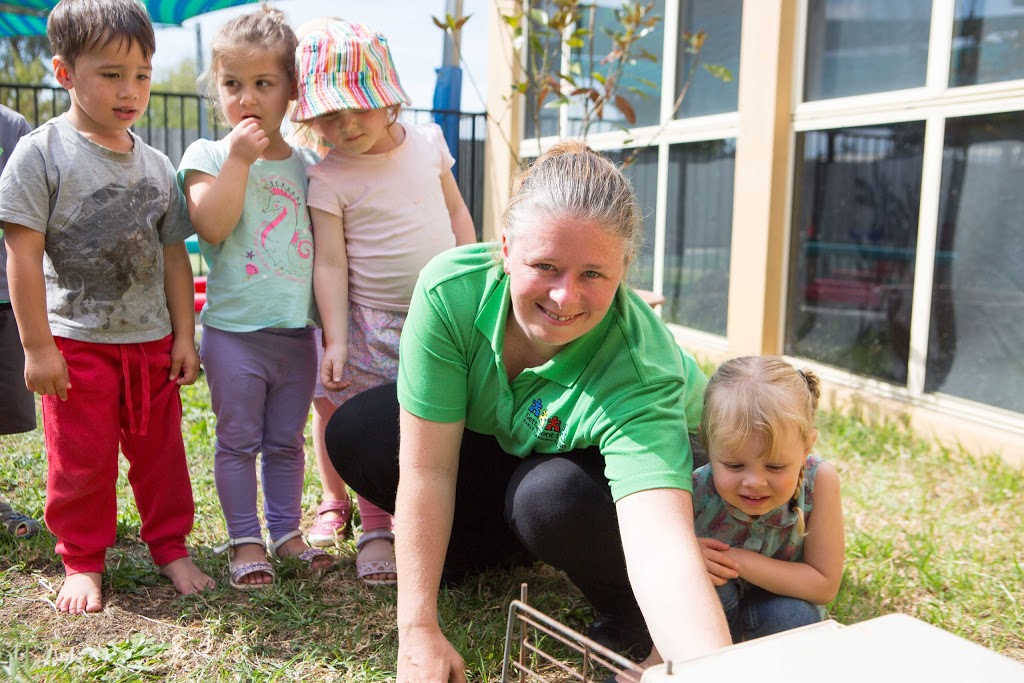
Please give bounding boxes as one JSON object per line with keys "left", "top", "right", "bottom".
{"left": 292, "top": 20, "right": 476, "bottom": 586}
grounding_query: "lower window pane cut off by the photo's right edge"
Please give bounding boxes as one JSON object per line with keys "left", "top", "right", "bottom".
{"left": 925, "top": 112, "right": 1024, "bottom": 413}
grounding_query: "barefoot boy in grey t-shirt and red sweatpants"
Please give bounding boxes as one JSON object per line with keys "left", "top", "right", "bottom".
{"left": 0, "top": 0, "right": 213, "bottom": 614}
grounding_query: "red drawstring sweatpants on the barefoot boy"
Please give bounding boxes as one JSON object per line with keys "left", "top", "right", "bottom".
{"left": 42, "top": 336, "right": 195, "bottom": 574}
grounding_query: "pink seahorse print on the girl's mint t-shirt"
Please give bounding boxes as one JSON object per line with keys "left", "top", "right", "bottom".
{"left": 246, "top": 175, "right": 313, "bottom": 282}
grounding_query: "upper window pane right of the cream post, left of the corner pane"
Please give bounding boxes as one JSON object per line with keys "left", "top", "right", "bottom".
{"left": 804, "top": 0, "right": 932, "bottom": 101}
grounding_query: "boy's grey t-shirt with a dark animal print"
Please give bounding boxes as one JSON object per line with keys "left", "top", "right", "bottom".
{"left": 0, "top": 116, "right": 193, "bottom": 344}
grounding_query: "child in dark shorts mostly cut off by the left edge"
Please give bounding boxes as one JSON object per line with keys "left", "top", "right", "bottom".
{"left": 0, "top": 104, "right": 39, "bottom": 539}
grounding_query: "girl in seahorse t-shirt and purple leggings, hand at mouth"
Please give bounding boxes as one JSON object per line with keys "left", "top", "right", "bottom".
{"left": 178, "top": 6, "right": 333, "bottom": 590}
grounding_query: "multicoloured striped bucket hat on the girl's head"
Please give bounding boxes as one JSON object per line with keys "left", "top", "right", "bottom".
{"left": 292, "top": 22, "right": 410, "bottom": 121}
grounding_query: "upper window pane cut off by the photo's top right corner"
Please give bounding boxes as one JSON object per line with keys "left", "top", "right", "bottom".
{"left": 949, "top": 0, "right": 1024, "bottom": 87}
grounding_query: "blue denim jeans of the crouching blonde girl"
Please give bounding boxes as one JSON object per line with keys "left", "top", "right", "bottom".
{"left": 716, "top": 579, "right": 821, "bottom": 643}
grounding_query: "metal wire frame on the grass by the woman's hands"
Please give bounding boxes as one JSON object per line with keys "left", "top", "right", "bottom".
{"left": 502, "top": 584, "right": 643, "bottom": 683}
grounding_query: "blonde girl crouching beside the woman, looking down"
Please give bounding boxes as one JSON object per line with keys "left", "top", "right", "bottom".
{"left": 646, "top": 356, "right": 844, "bottom": 664}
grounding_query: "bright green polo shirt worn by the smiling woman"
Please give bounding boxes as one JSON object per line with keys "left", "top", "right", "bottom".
{"left": 398, "top": 244, "right": 707, "bottom": 501}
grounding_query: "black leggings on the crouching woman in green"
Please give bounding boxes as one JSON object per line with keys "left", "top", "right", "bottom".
{"left": 327, "top": 384, "right": 643, "bottom": 624}
